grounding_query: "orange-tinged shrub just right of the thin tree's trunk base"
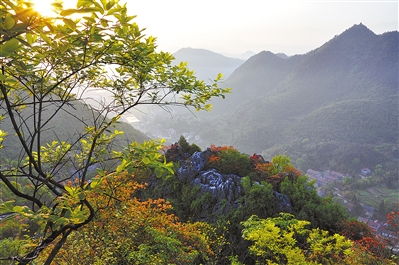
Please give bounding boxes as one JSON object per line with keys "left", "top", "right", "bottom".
{"left": 39, "top": 174, "right": 216, "bottom": 264}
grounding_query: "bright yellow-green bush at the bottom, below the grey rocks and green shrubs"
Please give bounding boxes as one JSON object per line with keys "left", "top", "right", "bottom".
{"left": 242, "top": 213, "right": 352, "bottom": 264}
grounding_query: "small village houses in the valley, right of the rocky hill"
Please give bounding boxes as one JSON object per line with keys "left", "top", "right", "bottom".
{"left": 306, "top": 168, "right": 399, "bottom": 253}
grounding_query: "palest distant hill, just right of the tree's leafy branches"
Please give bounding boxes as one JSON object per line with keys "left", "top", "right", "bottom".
{"left": 173, "top": 48, "right": 244, "bottom": 82}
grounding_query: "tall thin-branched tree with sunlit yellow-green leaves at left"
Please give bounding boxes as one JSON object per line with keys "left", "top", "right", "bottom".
{"left": 0, "top": 0, "right": 229, "bottom": 264}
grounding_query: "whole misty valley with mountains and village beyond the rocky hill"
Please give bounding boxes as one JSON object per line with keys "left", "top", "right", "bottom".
{"left": 122, "top": 24, "right": 399, "bottom": 220}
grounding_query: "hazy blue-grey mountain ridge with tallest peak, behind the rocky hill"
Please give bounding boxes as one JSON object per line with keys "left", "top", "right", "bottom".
{"left": 149, "top": 24, "right": 399, "bottom": 169}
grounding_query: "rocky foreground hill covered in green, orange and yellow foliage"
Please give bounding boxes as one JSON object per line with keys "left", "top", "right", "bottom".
{"left": 0, "top": 137, "right": 399, "bottom": 265}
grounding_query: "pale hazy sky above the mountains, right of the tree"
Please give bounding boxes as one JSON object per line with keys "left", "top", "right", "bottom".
{"left": 126, "top": 0, "right": 398, "bottom": 55}
